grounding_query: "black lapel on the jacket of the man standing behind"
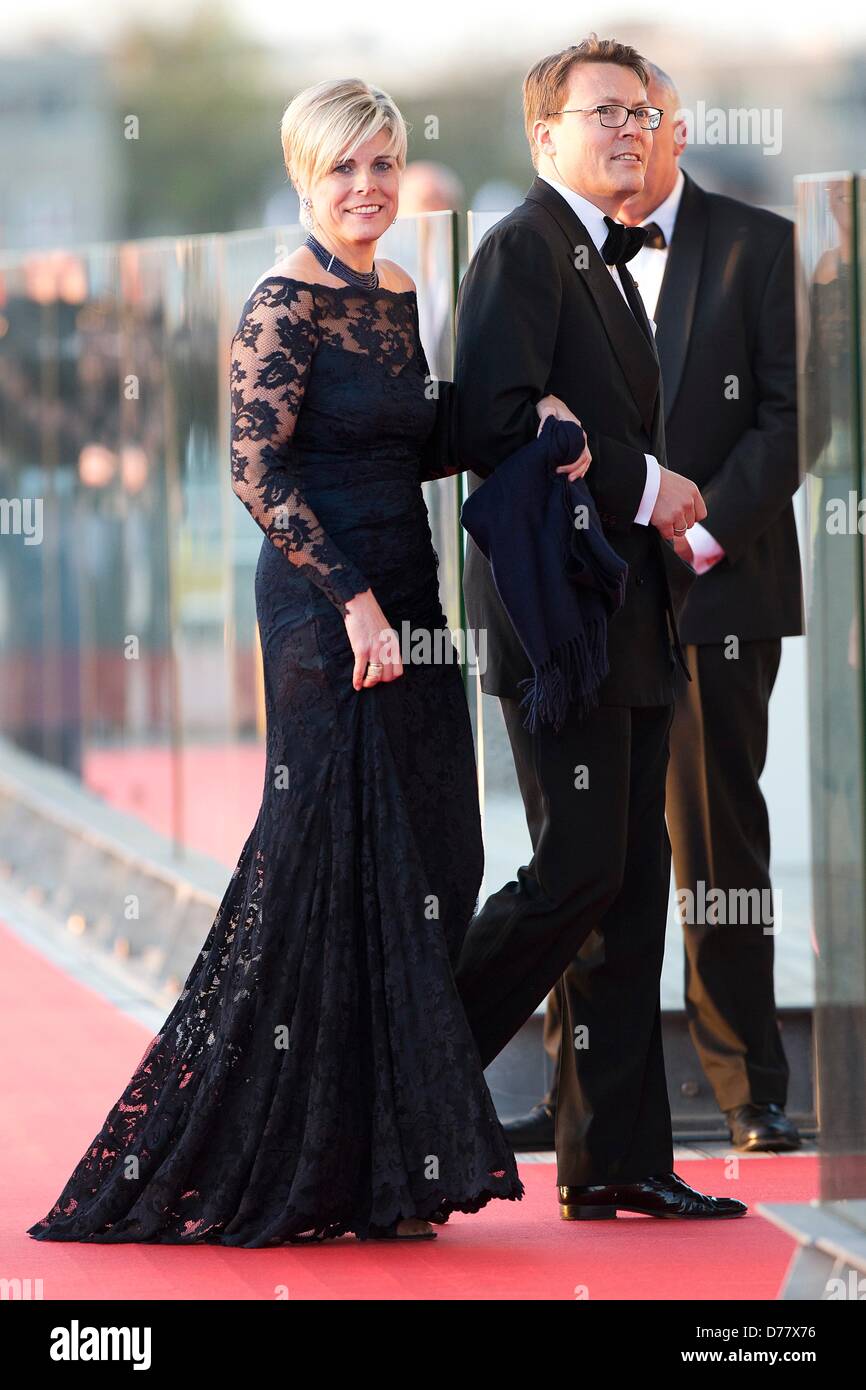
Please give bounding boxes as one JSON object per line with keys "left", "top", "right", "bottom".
{"left": 656, "top": 174, "right": 708, "bottom": 418}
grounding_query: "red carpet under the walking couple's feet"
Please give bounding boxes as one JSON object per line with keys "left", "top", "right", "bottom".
{"left": 0, "top": 926, "right": 817, "bottom": 1300}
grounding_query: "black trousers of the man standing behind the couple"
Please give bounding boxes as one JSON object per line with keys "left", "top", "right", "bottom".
{"left": 545, "top": 638, "right": 788, "bottom": 1111}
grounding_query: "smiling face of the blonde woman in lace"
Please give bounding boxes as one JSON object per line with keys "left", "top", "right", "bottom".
{"left": 310, "top": 131, "right": 400, "bottom": 245}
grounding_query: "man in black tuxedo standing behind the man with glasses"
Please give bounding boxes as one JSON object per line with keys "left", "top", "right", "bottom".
{"left": 506, "top": 64, "right": 803, "bottom": 1151}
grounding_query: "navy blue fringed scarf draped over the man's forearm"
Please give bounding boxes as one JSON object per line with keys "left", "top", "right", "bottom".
{"left": 460, "top": 416, "right": 628, "bottom": 733}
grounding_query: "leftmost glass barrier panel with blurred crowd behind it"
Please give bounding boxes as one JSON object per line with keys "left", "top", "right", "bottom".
{"left": 0, "top": 243, "right": 174, "bottom": 827}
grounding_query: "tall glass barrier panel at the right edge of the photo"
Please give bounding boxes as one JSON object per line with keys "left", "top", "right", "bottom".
{"left": 796, "top": 174, "right": 866, "bottom": 1200}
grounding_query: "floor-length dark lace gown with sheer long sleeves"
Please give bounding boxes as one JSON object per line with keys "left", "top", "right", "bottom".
{"left": 29, "top": 275, "right": 523, "bottom": 1247}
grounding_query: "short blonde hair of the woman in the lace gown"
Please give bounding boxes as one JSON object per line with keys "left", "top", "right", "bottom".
{"left": 279, "top": 78, "right": 409, "bottom": 201}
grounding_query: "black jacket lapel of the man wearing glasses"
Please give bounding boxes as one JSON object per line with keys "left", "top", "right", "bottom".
{"left": 527, "top": 178, "right": 659, "bottom": 432}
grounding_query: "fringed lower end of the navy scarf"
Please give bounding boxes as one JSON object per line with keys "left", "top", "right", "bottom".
{"left": 518, "top": 619, "right": 609, "bottom": 733}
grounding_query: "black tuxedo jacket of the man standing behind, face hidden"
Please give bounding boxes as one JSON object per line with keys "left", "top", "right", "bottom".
{"left": 656, "top": 175, "right": 803, "bottom": 642}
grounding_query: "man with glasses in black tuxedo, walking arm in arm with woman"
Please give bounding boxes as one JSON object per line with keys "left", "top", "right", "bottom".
{"left": 455, "top": 36, "right": 745, "bottom": 1219}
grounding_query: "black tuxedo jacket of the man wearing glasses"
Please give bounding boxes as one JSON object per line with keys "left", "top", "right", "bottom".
{"left": 455, "top": 178, "right": 694, "bottom": 705}
